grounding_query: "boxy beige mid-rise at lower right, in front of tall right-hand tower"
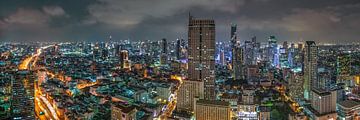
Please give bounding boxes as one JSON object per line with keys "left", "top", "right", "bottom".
{"left": 309, "top": 89, "right": 337, "bottom": 120}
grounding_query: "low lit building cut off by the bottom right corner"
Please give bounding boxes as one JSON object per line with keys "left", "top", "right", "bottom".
{"left": 337, "top": 100, "right": 360, "bottom": 120}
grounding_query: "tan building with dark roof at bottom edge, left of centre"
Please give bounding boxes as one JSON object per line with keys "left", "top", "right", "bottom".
{"left": 111, "top": 103, "right": 137, "bottom": 120}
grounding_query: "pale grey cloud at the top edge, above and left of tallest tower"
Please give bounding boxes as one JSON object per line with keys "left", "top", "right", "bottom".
{"left": 89, "top": 0, "right": 244, "bottom": 28}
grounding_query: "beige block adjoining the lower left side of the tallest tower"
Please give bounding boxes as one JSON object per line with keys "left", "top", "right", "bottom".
{"left": 176, "top": 80, "right": 204, "bottom": 111}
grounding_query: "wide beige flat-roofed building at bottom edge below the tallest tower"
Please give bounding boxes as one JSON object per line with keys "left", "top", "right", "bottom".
{"left": 195, "top": 100, "right": 231, "bottom": 120}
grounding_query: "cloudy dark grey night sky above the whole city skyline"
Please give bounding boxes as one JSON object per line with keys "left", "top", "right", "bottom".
{"left": 0, "top": 0, "right": 360, "bottom": 43}
